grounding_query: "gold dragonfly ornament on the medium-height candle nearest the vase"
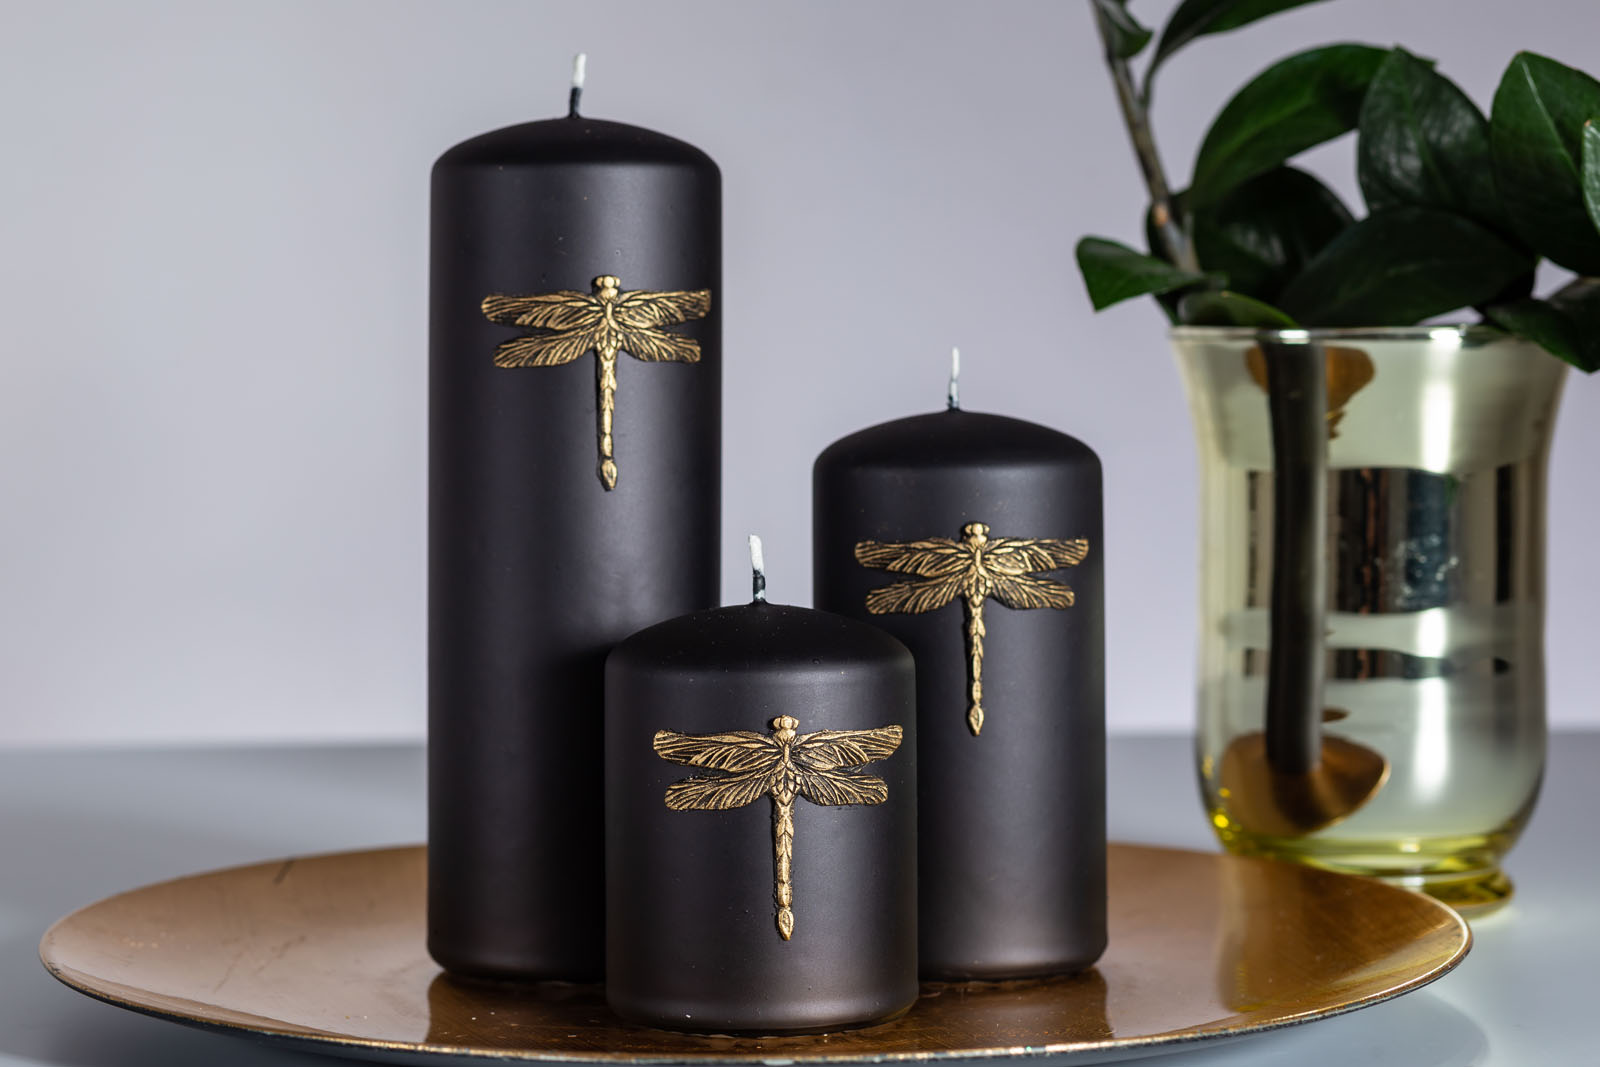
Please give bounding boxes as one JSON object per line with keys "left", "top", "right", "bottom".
{"left": 856, "top": 523, "right": 1090, "bottom": 737}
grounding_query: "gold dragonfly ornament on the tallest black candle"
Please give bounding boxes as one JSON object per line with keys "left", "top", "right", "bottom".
{"left": 483, "top": 274, "right": 710, "bottom": 491}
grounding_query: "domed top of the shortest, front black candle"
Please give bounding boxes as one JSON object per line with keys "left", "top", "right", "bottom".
{"left": 608, "top": 600, "right": 914, "bottom": 672}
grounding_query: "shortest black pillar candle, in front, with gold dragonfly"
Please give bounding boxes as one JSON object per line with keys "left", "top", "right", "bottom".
{"left": 605, "top": 543, "right": 917, "bottom": 1033}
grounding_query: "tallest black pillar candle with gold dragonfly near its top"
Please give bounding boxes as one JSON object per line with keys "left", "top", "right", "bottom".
{"left": 427, "top": 68, "right": 722, "bottom": 981}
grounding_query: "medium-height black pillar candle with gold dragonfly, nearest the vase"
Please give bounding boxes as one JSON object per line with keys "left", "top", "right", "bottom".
{"left": 813, "top": 379, "right": 1106, "bottom": 979}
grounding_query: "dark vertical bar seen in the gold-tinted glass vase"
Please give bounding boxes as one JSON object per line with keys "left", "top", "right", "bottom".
{"left": 1261, "top": 341, "right": 1328, "bottom": 774}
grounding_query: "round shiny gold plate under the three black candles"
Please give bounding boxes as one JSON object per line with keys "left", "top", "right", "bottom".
{"left": 40, "top": 845, "right": 1472, "bottom": 1064}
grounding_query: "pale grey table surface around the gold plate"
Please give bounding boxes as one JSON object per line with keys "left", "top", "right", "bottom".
{"left": 0, "top": 733, "right": 1600, "bottom": 1067}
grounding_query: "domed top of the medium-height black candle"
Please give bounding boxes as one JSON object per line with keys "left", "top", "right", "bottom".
{"left": 816, "top": 408, "right": 1099, "bottom": 470}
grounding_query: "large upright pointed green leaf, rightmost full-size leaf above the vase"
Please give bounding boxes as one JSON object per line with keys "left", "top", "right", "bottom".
{"left": 1490, "top": 51, "right": 1600, "bottom": 275}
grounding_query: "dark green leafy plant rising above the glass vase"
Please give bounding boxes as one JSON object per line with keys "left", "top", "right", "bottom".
{"left": 1077, "top": 0, "right": 1600, "bottom": 371}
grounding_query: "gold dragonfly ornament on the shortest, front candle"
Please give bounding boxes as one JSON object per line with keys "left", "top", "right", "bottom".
{"left": 654, "top": 715, "right": 904, "bottom": 941}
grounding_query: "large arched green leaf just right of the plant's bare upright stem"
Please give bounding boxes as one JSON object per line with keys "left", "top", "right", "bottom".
{"left": 1189, "top": 45, "right": 1389, "bottom": 206}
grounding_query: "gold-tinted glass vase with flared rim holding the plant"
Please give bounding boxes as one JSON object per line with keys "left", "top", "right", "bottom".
{"left": 1173, "top": 326, "right": 1565, "bottom": 907}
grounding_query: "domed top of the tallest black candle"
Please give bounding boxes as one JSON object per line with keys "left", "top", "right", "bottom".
{"left": 434, "top": 115, "right": 717, "bottom": 170}
